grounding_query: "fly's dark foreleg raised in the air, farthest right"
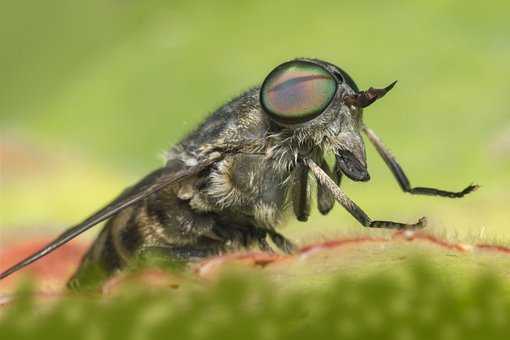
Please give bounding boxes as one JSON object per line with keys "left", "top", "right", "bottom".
{"left": 363, "top": 126, "right": 478, "bottom": 198}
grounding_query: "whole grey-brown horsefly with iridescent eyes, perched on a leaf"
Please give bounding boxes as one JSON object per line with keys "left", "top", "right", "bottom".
{"left": 0, "top": 58, "right": 477, "bottom": 287}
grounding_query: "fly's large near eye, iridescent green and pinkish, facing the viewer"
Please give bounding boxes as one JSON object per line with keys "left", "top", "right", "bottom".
{"left": 260, "top": 61, "right": 337, "bottom": 124}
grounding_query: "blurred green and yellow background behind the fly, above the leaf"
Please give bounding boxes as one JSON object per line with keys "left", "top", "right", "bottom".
{"left": 0, "top": 0, "right": 510, "bottom": 243}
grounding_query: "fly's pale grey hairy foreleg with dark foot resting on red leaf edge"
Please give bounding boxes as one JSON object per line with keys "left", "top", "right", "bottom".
{"left": 305, "top": 159, "right": 427, "bottom": 229}
